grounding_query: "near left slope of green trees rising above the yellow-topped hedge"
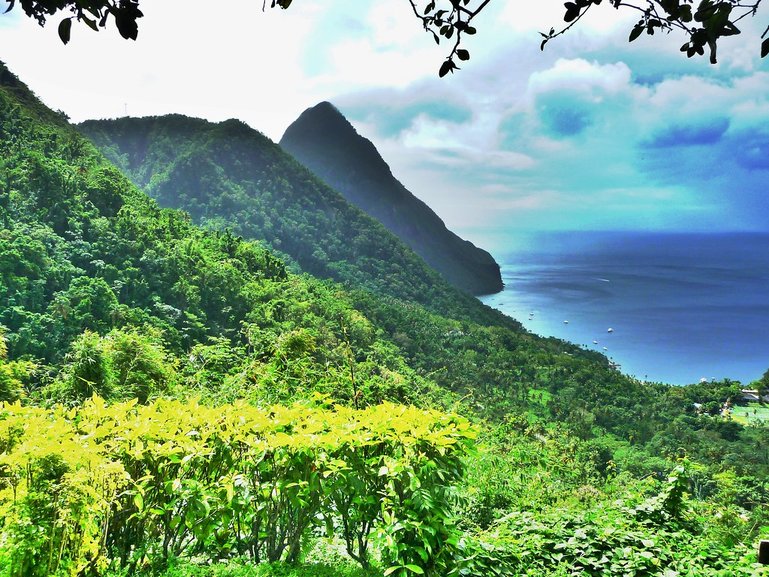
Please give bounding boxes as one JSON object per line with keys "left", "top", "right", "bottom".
{"left": 0, "top": 64, "right": 450, "bottom": 410}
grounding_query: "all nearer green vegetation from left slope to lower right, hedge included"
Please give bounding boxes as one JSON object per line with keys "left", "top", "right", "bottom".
{"left": 0, "top": 60, "right": 769, "bottom": 577}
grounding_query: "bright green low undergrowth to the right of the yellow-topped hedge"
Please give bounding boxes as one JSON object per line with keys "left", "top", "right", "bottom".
{"left": 452, "top": 428, "right": 769, "bottom": 577}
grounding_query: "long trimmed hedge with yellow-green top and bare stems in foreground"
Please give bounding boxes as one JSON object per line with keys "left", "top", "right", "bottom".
{"left": 0, "top": 397, "right": 475, "bottom": 577}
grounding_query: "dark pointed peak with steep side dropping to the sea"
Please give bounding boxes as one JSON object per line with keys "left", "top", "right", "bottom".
{"left": 280, "top": 102, "right": 502, "bottom": 294}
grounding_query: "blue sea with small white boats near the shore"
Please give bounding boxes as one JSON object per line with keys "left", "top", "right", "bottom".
{"left": 481, "top": 232, "right": 769, "bottom": 384}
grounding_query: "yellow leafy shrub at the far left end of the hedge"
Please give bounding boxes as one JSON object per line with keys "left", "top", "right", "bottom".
{"left": 0, "top": 403, "right": 128, "bottom": 577}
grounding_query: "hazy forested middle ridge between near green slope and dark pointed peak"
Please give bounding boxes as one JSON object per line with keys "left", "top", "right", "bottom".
{"left": 78, "top": 115, "right": 502, "bottom": 322}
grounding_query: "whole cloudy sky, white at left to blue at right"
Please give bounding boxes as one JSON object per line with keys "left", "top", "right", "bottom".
{"left": 0, "top": 0, "right": 769, "bottom": 248}
